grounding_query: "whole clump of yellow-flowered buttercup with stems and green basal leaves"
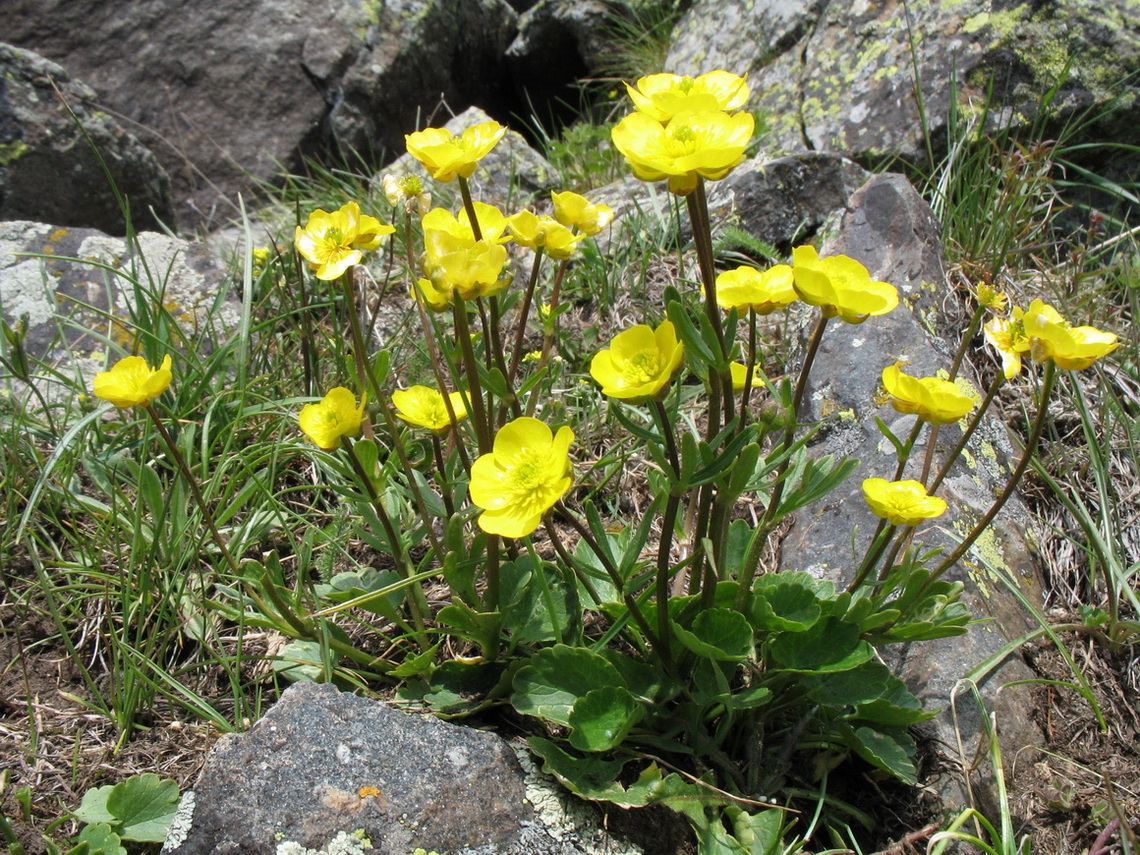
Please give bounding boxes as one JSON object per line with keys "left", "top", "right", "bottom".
{"left": 97, "top": 71, "right": 1116, "bottom": 855}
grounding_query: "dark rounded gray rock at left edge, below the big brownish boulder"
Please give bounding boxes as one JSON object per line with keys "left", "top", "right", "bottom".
{"left": 0, "top": 44, "right": 173, "bottom": 235}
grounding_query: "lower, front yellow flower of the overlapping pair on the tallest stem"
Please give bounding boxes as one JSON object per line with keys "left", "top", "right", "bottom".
{"left": 610, "top": 111, "right": 755, "bottom": 196}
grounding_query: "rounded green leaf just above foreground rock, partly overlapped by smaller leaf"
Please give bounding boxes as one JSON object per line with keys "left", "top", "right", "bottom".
{"left": 511, "top": 644, "right": 626, "bottom": 726}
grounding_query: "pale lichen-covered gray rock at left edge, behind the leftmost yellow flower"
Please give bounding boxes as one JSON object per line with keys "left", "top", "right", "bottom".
{"left": 0, "top": 220, "right": 233, "bottom": 399}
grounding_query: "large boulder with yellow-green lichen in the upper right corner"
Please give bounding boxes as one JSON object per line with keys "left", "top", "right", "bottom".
{"left": 667, "top": 0, "right": 1140, "bottom": 161}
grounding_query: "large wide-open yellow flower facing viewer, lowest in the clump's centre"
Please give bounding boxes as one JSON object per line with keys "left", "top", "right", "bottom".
{"left": 469, "top": 417, "right": 573, "bottom": 537}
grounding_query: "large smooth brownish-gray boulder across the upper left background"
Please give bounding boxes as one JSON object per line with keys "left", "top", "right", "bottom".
{"left": 5, "top": 0, "right": 516, "bottom": 227}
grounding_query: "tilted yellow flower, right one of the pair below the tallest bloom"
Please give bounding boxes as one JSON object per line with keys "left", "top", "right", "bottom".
{"left": 792, "top": 246, "right": 898, "bottom": 324}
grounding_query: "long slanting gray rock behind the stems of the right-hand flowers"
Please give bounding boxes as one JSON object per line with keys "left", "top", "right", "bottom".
{"left": 781, "top": 174, "right": 1042, "bottom": 807}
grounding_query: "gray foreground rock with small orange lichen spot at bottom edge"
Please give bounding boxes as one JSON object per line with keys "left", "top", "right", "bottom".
{"left": 163, "top": 683, "right": 656, "bottom": 855}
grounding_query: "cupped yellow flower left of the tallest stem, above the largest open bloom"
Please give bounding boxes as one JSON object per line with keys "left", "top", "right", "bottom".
{"left": 589, "top": 320, "right": 685, "bottom": 404}
